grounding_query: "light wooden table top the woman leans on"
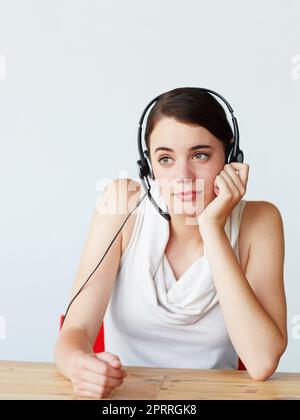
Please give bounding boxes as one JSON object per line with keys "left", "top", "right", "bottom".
{"left": 0, "top": 362, "right": 300, "bottom": 400}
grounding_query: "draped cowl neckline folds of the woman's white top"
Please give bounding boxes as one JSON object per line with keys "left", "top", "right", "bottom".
{"left": 139, "top": 180, "right": 231, "bottom": 325}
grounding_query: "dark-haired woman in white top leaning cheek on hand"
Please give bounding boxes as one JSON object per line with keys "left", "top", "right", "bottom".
{"left": 55, "top": 88, "right": 287, "bottom": 398}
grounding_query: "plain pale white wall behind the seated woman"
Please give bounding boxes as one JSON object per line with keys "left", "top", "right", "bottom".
{"left": 0, "top": 0, "right": 300, "bottom": 372}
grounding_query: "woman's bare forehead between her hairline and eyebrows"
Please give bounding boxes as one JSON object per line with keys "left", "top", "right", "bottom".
{"left": 150, "top": 118, "right": 219, "bottom": 150}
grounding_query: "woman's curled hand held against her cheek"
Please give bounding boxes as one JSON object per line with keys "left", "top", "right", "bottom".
{"left": 198, "top": 162, "right": 249, "bottom": 233}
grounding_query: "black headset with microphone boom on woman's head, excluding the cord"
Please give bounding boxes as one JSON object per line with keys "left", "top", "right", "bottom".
{"left": 137, "top": 88, "right": 244, "bottom": 221}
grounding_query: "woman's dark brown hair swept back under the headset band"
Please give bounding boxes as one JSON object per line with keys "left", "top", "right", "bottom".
{"left": 145, "top": 87, "right": 233, "bottom": 160}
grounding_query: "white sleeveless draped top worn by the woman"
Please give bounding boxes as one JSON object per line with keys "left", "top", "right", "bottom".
{"left": 104, "top": 181, "right": 246, "bottom": 369}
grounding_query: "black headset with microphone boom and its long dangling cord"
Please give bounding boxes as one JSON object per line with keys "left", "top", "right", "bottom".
{"left": 62, "top": 88, "right": 244, "bottom": 324}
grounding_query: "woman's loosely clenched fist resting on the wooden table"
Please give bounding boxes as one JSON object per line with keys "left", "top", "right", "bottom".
{"left": 70, "top": 352, "right": 127, "bottom": 399}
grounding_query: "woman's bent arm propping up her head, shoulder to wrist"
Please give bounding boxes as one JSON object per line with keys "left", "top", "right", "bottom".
{"left": 201, "top": 201, "right": 287, "bottom": 380}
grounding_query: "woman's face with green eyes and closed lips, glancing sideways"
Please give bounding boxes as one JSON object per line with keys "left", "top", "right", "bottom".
{"left": 149, "top": 117, "right": 225, "bottom": 216}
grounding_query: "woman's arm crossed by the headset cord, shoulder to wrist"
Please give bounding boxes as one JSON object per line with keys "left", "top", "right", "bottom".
{"left": 55, "top": 179, "right": 138, "bottom": 378}
